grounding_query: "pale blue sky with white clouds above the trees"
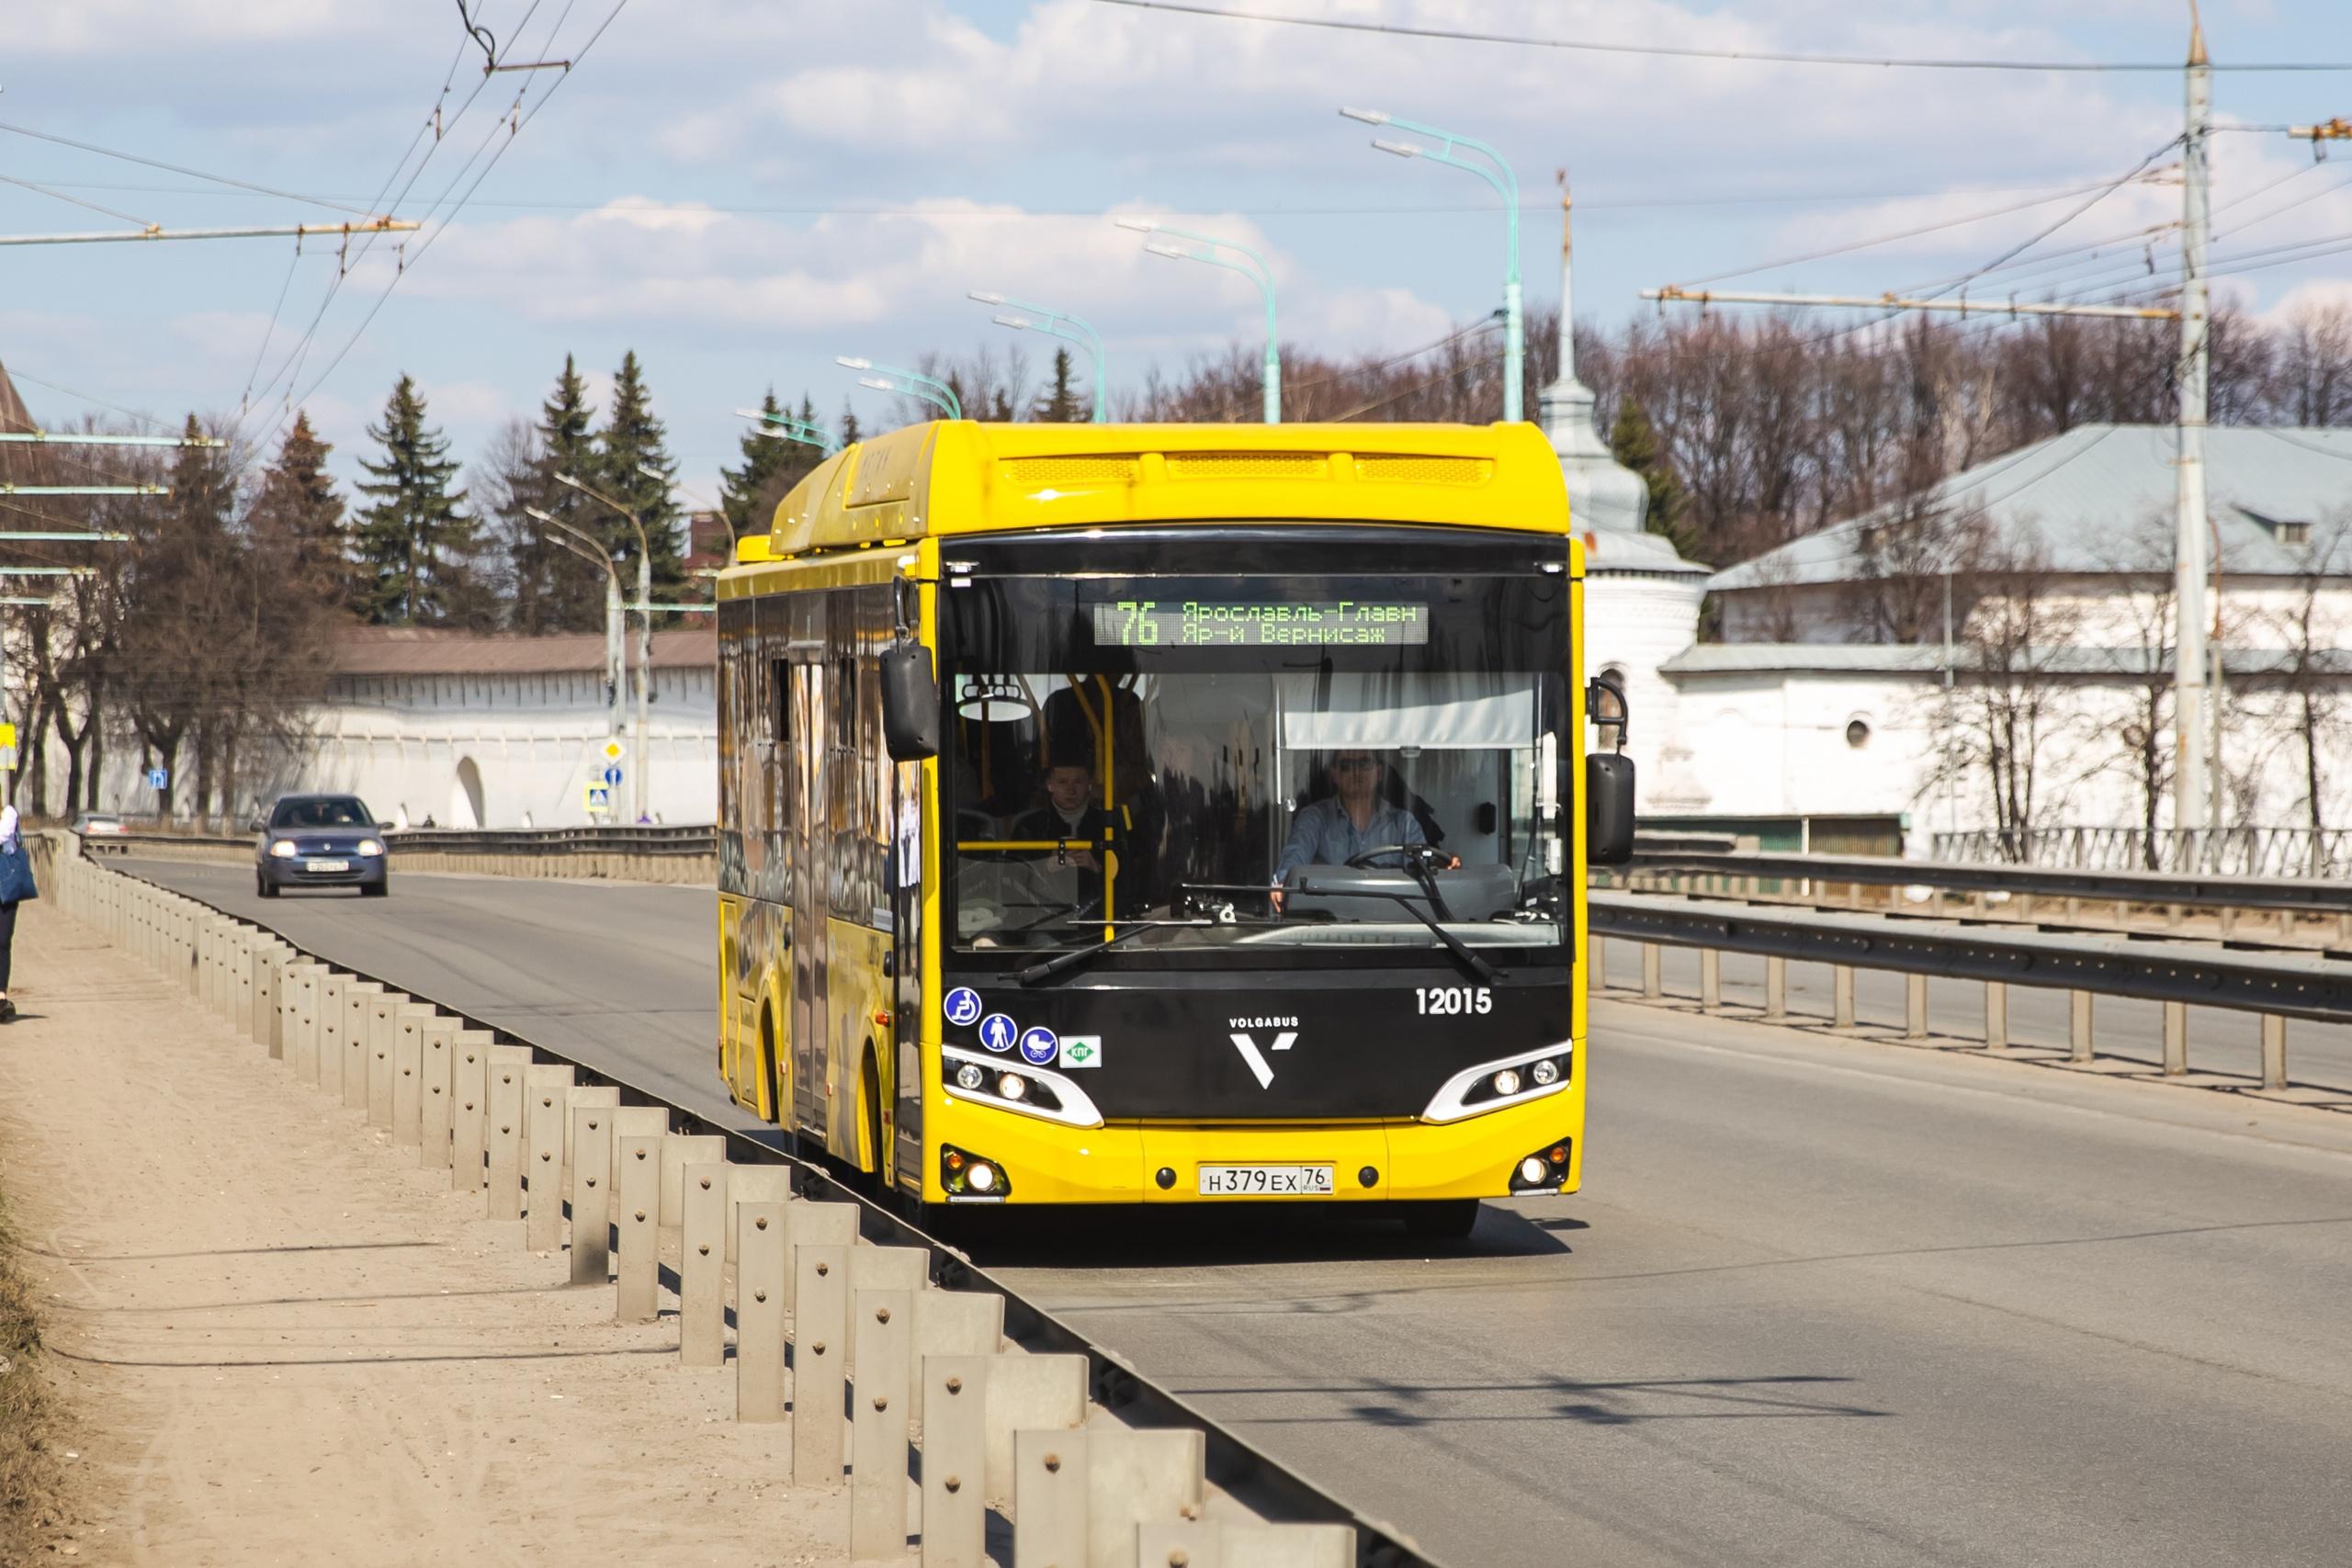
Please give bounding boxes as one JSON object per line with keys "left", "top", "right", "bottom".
{"left": 0, "top": 0, "right": 2352, "bottom": 496}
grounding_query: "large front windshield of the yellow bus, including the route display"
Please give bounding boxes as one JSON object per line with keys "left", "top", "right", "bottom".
{"left": 941, "top": 573, "right": 1569, "bottom": 957}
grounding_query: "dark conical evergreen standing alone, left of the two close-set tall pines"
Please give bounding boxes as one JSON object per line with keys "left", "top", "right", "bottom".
{"left": 353, "top": 374, "right": 475, "bottom": 626}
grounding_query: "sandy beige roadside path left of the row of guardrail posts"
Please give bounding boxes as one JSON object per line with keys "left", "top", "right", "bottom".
{"left": 0, "top": 905, "right": 847, "bottom": 1568}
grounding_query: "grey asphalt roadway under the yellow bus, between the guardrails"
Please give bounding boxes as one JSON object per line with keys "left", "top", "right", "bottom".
{"left": 124, "top": 863, "right": 2352, "bottom": 1568}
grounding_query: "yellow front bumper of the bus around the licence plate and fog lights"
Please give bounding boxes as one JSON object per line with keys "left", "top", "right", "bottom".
{"left": 924, "top": 1072, "right": 1585, "bottom": 1203}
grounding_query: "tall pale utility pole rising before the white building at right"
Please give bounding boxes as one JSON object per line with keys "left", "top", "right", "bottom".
{"left": 2173, "top": 18, "right": 2221, "bottom": 846}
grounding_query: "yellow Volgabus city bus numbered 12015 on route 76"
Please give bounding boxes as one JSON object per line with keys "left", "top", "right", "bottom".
{"left": 718, "top": 421, "right": 1633, "bottom": 1235}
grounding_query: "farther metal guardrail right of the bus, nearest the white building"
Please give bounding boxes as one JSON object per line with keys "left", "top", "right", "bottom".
{"left": 1633, "top": 844, "right": 2352, "bottom": 915}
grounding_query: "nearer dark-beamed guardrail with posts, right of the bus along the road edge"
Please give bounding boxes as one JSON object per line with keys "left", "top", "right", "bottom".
{"left": 1588, "top": 894, "right": 2352, "bottom": 1090}
